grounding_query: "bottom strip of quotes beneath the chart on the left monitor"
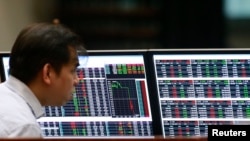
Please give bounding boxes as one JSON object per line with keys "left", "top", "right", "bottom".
{"left": 40, "top": 121, "right": 152, "bottom": 137}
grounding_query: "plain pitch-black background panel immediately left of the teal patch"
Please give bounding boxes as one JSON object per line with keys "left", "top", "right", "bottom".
{"left": 163, "top": 0, "right": 226, "bottom": 48}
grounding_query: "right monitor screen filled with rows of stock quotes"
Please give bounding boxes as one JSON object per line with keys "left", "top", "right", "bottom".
{"left": 153, "top": 54, "right": 250, "bottom": 137}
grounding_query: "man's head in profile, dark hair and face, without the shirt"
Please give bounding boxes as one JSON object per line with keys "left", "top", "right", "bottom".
{"left": 9, "top": 23, "right": 86, "bottom": 105}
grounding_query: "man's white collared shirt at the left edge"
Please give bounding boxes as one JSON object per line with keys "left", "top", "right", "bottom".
{"left": 0, "top": 76, "right": 44, "bottom": 138}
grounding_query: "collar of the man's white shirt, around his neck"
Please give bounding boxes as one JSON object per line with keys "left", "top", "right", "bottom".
{"left": 6, "top": 75, "right": 44, "bottom": 118}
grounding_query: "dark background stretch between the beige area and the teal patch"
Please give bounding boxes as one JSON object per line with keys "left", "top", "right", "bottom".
{"left": 55, "top": 0, "right": 226, "bottom": 49}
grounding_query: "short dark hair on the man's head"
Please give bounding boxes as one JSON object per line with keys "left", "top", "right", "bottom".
{"left": 9, "top": 23, "right": 86, "bottom": 84}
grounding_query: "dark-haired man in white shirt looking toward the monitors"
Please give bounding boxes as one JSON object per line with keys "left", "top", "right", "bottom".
{"left": 0, "top": 23, "right": 86, "bottom": 138}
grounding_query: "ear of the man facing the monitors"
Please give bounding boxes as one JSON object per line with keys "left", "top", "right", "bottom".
{"left": 42, "top": 63, "right": 53, "bottom": 84}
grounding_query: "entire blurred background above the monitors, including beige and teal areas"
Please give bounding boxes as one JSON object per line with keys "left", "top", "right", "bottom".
{"left": 0, "top": 0, "right": 250, "bottom": 51}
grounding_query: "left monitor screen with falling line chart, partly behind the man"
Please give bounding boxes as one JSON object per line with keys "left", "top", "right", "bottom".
{"left": 38, "top": 55, "right": 154, "bottom": 138}
